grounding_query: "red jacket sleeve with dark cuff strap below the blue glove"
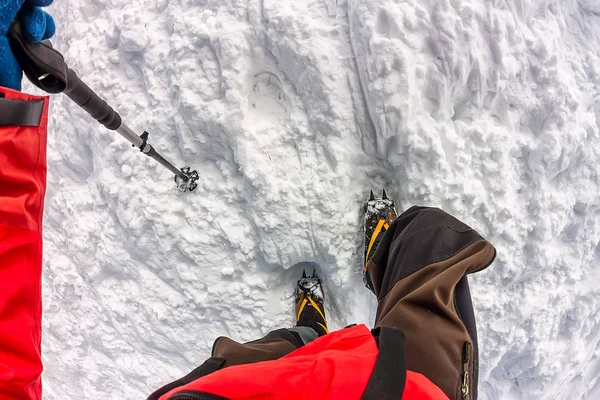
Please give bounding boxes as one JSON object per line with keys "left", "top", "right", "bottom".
{"left": 0, "top": 88, "right": 48, "bottom": 400}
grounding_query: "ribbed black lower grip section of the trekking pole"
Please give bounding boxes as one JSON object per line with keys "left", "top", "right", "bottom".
{"left": 64, "top": 68, "right": 121, "bottom": 131}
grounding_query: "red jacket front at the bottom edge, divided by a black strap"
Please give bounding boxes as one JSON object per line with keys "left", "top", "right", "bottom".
{"left": 160, "top": 325, "right": 448, "bottom": 400}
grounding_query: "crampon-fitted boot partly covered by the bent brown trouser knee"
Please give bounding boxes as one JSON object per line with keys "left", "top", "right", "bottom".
{"left": 363, "top": 189, "right": 398, "bottom": 292}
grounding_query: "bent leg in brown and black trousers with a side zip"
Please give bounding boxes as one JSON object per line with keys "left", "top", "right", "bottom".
{"left": 368, "top": 207, "right": 496, "bottom": 399}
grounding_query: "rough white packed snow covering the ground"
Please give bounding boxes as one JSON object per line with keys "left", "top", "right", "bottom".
{"left": 36, "top": 0, "right": 600, "bottom": 400}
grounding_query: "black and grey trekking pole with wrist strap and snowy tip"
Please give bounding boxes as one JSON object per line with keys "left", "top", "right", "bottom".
{"left": 8, "top": 18, "right": 199, "bottom": 192}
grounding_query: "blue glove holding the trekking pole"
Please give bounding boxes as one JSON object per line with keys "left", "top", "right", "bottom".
{"left": 0, "top": 0, "right": 56, "bottom": 90}
